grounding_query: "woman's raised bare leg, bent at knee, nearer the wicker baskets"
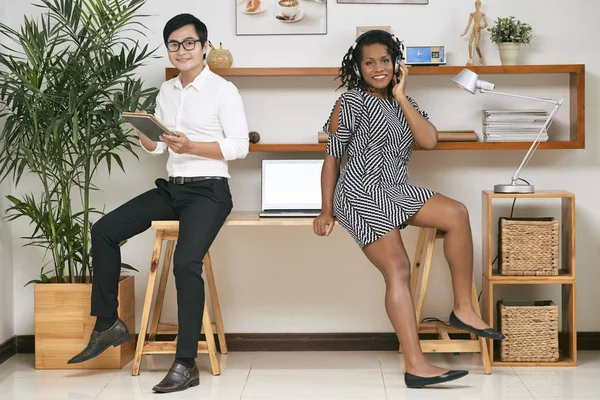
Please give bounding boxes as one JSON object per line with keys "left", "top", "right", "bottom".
{"left": 407, "top": 194, "right": 489, "bottom": 329}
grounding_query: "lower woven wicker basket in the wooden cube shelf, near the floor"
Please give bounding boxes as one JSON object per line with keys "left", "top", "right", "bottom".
{"left": 498, "top": 301, "right": 559, "bottom": 362}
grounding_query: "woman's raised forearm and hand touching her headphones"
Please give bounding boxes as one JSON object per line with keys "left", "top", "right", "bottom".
{"left": 394, "top": 62, "right": 438, "bottom": 150}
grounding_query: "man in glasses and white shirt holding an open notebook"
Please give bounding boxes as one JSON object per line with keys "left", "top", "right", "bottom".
{"left": 69, "top": 14, "right": 248, "bottom": 392}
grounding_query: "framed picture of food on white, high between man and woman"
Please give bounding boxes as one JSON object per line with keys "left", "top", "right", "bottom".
{"left": 235, "top": 0, "right": 327, "bottom": 36}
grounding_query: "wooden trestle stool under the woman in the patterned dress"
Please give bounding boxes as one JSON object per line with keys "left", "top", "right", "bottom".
{"left": 400, "top": 228, "right": 492, "bottom": 375}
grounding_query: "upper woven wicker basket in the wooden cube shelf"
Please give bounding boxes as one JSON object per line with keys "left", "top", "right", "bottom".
{"left": 498, "top": 217, "right": 559, "bottom": 276}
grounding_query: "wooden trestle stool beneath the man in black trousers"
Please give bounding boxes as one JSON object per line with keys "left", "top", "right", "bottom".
{"left": 132, "top": 221, "right": 227, "bottom": 375}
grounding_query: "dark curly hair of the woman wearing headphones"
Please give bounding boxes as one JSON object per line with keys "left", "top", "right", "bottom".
{"left": 336, "top": 29, "right": 403, "bottom": 94}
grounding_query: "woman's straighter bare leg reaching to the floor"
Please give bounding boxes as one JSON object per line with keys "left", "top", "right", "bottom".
{"left": 363, "top": 229, "right": 448, "bottom": 377}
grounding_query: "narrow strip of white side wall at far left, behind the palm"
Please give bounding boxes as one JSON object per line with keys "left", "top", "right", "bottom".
{"left": 0, "top": 2, "right": 15, "bottom": 344}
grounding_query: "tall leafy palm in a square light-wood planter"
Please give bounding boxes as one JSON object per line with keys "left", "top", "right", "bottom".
{"left": 0, "top": 0, "right": 157, "bottom": 368}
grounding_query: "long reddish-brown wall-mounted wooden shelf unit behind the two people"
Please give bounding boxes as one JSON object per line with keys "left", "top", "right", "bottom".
{"left": 165, "top": 64, "right": 585, "bottom": 152}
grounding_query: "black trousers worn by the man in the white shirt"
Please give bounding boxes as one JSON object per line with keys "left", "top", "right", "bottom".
{"left": 91, "top": 179, "right": 233, "bottom": 358}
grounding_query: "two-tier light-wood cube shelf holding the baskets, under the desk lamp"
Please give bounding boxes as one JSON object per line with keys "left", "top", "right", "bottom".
{"left": 481, "top": 190, "right": 577, "bottom": 367}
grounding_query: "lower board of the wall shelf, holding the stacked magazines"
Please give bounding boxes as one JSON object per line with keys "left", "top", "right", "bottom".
{"left": 250, "top": 141, "right": 582, "bottom": 153}
